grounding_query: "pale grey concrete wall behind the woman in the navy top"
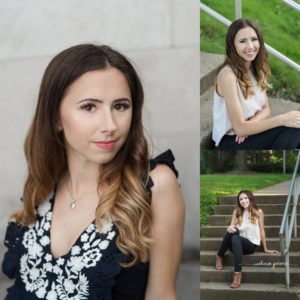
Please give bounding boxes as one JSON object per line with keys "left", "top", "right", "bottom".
{"left": 0, "top": 0, "right": 200, "bottom": 259}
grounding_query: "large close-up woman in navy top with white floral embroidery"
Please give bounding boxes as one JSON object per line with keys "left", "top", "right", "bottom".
{"left": 3, "top": 44, "right": 184, "bottom": 300}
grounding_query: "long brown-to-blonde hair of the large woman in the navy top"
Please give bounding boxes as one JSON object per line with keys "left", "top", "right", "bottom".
{"left": 13, "top": 44, "right": 152, "bottom": 266}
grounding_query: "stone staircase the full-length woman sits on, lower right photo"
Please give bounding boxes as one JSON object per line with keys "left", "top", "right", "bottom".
{"left": 200, "top": 195, "right": 300, "bottom": 300}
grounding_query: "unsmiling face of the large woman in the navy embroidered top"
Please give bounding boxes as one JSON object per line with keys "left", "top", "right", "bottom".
{"left": 59, "top": 68, "right": 132, "bottom": 164}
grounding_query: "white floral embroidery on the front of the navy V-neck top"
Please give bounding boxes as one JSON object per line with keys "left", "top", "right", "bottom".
{"left": 20, "top": 194, "right": 116, "bottom": 300}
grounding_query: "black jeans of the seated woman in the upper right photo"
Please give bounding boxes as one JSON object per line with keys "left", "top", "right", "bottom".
{"left": 218, "top": 126, "right": 300, "bottom": 150}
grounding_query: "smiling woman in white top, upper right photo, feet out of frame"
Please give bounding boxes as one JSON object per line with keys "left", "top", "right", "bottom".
{"left": 212, "top": 19, "right": 300, "bottom": 150}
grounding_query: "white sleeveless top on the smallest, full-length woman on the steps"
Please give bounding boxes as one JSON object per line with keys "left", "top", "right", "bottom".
{"left": 236, "top": 209, "right": 260, "bottom": 246}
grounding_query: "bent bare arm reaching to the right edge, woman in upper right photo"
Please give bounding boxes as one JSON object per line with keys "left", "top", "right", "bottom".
{"left": 218, "top": 70, "right": 300, "bottom": 137}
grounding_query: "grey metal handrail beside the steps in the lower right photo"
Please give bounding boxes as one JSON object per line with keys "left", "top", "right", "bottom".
{"left": 279, "top": 151, "right": 300, "bottom": 288}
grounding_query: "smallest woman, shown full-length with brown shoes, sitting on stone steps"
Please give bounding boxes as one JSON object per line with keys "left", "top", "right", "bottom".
{"left": 216, "top": 190, "right": 277, "bottom": 288}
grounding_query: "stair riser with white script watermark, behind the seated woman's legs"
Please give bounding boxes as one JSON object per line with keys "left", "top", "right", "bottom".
{"left": 200, "top": 253, "right": 300, "bottom": 266}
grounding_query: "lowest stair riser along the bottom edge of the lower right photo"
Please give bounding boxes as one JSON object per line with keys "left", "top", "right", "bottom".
{"left": 200, "top": 286, "right": 299, "bottom": 300}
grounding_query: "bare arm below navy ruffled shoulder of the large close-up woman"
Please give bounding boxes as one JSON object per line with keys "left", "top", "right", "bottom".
{"left": 145, "top": 165, "right": 184, "bottom": 300}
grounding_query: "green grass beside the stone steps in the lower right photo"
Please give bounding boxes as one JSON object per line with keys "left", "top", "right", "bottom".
{"left": 200, "top": 174, "right": 291, "bottom": 225}
